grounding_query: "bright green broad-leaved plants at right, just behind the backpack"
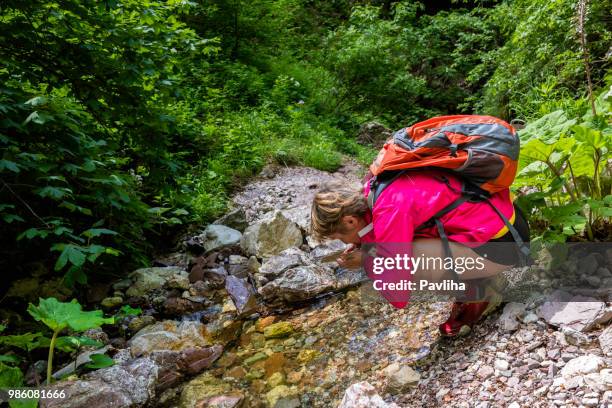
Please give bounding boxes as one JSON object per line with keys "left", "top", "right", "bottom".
{"left": 515, "top": 86, "right": 612, "bottom": 240}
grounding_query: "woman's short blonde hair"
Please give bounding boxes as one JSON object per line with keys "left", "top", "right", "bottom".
{"left": 310, "top": 183, "right": 368, "bottom": 239}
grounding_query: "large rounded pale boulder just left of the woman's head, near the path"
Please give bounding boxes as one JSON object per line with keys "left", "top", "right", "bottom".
{"left": 240, "top": 210, "right": 303, "bottom": 258}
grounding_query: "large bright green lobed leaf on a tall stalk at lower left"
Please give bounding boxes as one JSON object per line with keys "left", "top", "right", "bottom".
{"left": 28, "top": 297, "right": 114, "bottom": 332}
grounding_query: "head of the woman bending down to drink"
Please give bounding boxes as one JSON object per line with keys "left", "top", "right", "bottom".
{"left": 310, "top": 183, "right": 368, "bottom": 244}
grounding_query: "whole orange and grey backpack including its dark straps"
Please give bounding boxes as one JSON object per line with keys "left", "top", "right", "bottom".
{"left": 367, "top": 115, "right": 529, "bottom": 266}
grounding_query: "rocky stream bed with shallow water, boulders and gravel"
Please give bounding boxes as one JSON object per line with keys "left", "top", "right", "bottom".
{"left": 10, "top": 163, "right": 612, "bottom": 408}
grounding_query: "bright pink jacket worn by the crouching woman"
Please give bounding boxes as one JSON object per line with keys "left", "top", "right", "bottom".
{"left": 361, "top": 170, "right": 514, "bottom": 308}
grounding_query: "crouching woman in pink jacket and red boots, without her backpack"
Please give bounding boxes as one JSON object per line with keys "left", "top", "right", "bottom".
{"left": 311, "top": 169, "right": 529, "bottom": 336}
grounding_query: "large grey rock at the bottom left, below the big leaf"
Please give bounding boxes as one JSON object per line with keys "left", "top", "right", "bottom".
{"left": 40, "top": 358, "right": 158, "bottom": 408}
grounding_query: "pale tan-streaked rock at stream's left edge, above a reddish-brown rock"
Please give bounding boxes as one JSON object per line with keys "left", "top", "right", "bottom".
{"left": 128, "top": 320, "right": 211, "bottom": 357}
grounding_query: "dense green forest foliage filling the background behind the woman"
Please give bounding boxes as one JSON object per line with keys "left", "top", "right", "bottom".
{"left": 0, "top": 0, "right": 611, "bottom": 302}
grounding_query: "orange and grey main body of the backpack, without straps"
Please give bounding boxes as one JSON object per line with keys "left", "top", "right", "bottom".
{"left": 370, "top": 115, "right": 519, "bottom": 194}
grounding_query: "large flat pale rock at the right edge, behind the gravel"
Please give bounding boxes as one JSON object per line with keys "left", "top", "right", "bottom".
{"left": 537, "top": 290, "right": 612, "bottom": 332}
